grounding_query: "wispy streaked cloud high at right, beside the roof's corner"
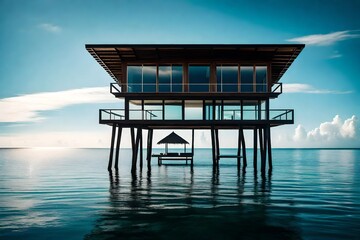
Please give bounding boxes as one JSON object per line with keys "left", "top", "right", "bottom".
{"left": 287, "top": 30, "right": 360, "bottom": 46}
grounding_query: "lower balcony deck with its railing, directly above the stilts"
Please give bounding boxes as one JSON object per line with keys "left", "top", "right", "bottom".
{"left": 99, "top": 109, "right": 294, "bottom": 128}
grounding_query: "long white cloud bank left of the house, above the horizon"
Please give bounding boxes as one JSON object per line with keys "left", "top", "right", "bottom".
{"left": 0, "top": 87, "right": 116, "bottom": 122}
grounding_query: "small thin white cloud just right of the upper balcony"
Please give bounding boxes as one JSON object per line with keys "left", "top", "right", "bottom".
{"left": 283, "top": 83, "right": 352, "bottom": 94}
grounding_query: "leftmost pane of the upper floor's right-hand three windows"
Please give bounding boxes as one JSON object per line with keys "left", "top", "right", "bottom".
{"left": 216, "top": 66, "right": 238, "bottom": 92}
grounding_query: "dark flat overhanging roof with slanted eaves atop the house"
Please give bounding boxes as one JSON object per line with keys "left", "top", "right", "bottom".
{"left": 85, "top": 44, "right": 305, "bottom": 83}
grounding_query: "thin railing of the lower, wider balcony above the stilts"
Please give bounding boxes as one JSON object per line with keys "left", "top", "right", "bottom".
{"left": 99, "top": 109, "right": 294, "bottom": 122}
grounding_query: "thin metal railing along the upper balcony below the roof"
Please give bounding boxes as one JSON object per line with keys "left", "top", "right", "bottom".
{"left": 110, "top": 83, "right": 282, "bottom": 94}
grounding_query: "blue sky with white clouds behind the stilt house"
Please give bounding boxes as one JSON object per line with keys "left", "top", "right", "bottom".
{"left": 0, "top": 0, "right": 360, "bottom": 148}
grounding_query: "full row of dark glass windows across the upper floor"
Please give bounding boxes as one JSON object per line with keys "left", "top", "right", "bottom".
{"left": 127, "top": 64, "right": 267, "bottom": 93}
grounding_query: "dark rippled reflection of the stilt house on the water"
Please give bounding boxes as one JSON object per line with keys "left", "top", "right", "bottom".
{"left": 85, "top": 166, "right": 299, "bottom": 239}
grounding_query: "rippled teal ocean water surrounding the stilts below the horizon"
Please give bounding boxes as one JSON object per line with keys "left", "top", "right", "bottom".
{"left": 0, "top": 149, "right": 360, "bottom": 239}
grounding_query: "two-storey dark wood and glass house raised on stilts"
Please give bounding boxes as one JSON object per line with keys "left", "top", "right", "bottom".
{"left": 86, "top": 44, "right": 304, "bottom": 171}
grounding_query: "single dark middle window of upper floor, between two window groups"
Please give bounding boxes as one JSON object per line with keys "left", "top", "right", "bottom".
{"left": 189, "top": 66, "right": 210, "bottom": 92}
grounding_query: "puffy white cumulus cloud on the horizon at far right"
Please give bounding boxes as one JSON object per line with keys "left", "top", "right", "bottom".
{"left": 293, "top": 115, "right": 360, "bottom": 148}
